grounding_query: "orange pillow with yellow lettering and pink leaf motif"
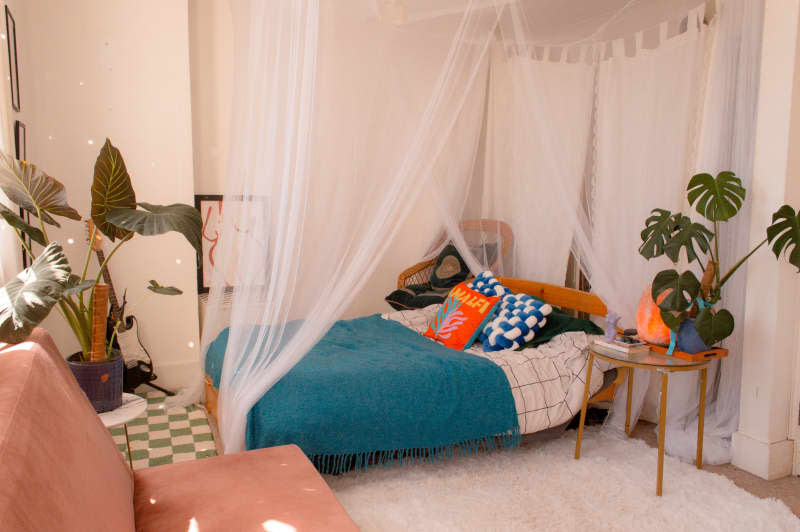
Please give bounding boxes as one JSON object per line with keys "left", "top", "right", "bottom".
{"left": 425, "top": 282, "right": 501, "bottom": 351}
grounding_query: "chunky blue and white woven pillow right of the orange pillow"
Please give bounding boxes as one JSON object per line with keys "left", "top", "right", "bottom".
{"left": 480, "top": 294, "right": 553, "bottom": 351}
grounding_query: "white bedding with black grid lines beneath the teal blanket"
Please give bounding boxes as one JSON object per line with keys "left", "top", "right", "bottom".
{"left": 382, "top": 305, "right": 611, "bottom": 434}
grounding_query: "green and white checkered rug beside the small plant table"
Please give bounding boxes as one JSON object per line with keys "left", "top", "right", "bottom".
{"left": 109, "top": 392, "right": 217, "bottom": 469}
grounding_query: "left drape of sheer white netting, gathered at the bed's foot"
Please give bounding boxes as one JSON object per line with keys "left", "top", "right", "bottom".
{"left": 204, "top": 0, "right": 504, "bottom": 452}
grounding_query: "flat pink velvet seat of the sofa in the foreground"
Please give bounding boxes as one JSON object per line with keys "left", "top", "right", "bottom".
{"left": 134, "top": 445, "right": 358, "bottom": 532}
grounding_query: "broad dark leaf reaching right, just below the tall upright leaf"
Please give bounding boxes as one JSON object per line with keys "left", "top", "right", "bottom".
{"left": 107, "top": 203, "right": 203, "bottom": 253}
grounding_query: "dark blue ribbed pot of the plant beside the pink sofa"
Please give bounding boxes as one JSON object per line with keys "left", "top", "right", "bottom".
{"left": 67, "top": 349, "right": 125, "bottom": 414}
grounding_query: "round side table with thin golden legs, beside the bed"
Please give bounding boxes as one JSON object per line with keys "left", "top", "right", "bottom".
{"left": 575, "top": 344, "right": 711, "bottom": 496}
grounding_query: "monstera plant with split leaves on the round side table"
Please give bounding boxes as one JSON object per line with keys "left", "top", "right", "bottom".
{"left": 639, "top": 172, "right": 800, "bottom": 346}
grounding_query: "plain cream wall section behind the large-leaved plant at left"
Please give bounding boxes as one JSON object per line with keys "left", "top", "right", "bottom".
{"left": 3, "top": 0, "right": 199, "bottom": 388}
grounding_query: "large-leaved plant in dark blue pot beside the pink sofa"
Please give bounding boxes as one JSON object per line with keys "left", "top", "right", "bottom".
{"left": 0, "top": 139, "right": 202, "bottom": 412}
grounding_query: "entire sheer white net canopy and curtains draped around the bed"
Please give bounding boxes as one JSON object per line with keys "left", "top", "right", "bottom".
{"left": 203, "top": 0, "right": 763, "bottom": 462}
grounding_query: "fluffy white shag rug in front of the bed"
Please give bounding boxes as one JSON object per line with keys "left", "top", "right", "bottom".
{"left": 326, "top": 427, "right": 800, "bottom": 532}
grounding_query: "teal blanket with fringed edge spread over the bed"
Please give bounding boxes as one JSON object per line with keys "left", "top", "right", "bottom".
{"left": 206, "top": 315, "right": 519, "bottom": 473}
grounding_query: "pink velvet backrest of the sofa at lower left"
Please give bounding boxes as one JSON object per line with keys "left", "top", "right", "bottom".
{"left": 0, "top": 329, "right": 134, "bottom": 532}
